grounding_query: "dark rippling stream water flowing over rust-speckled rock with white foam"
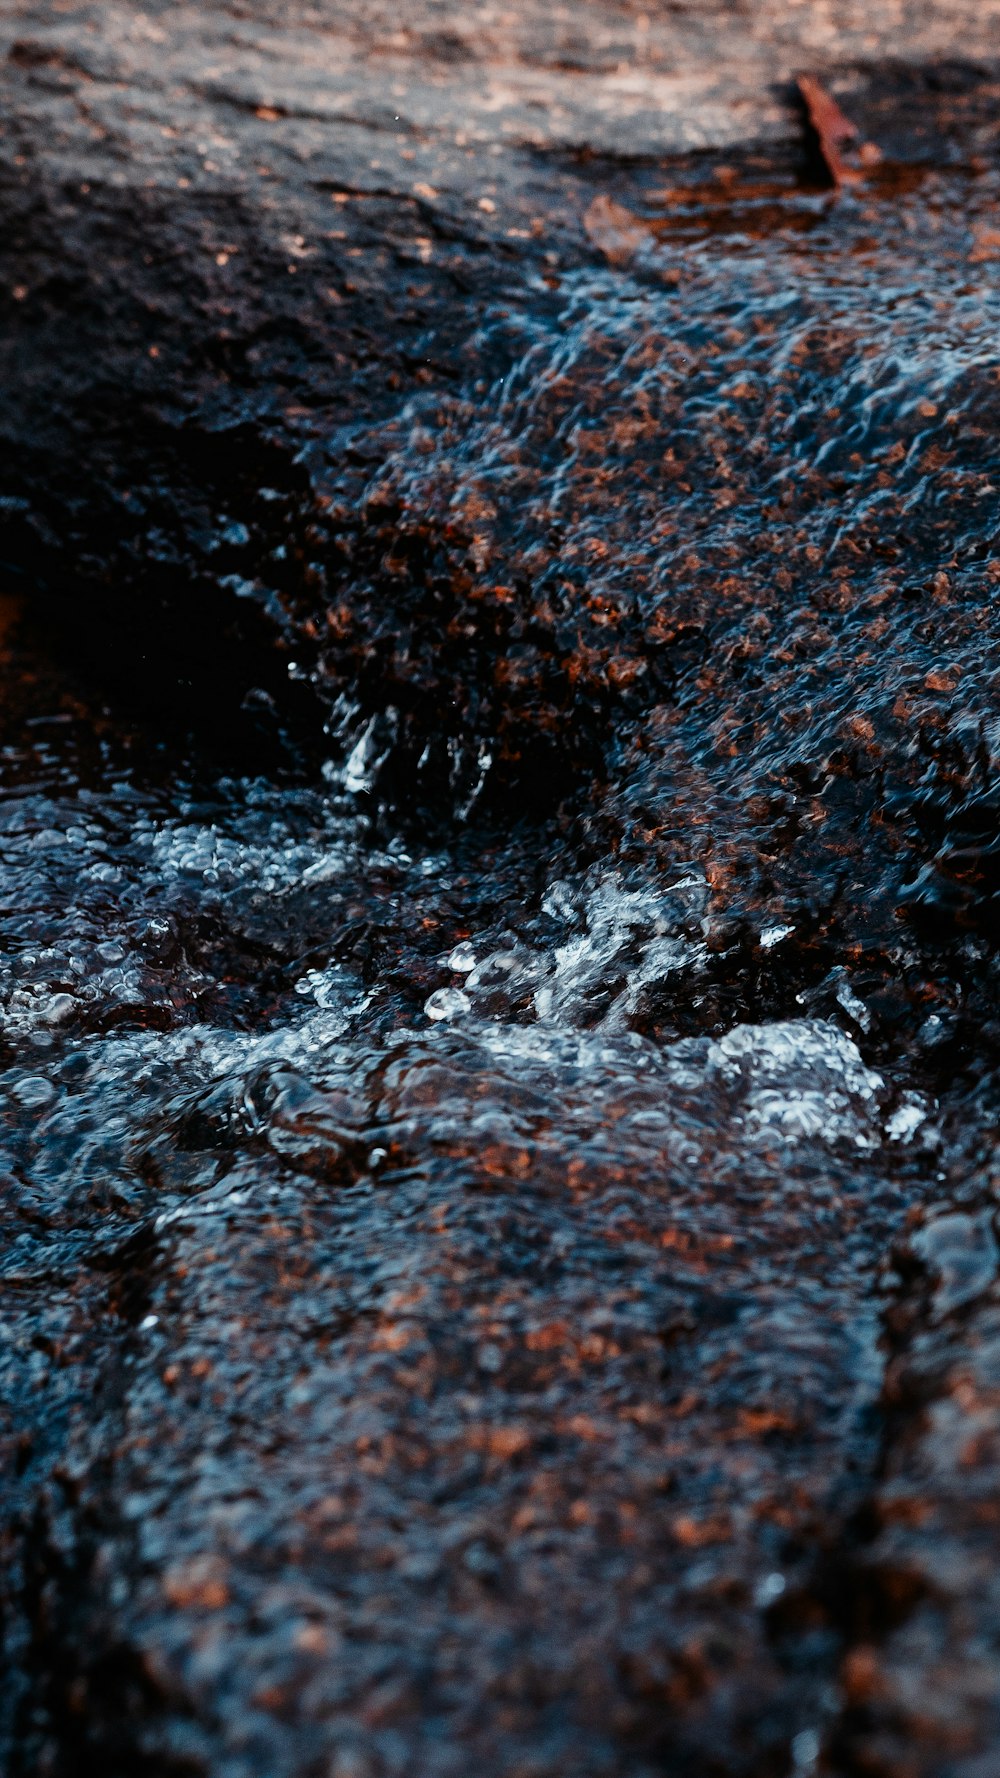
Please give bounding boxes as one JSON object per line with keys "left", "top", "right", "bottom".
{"left": 0, "top": 160, "right": 1000, "bottom": 1778}
